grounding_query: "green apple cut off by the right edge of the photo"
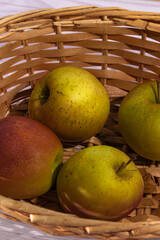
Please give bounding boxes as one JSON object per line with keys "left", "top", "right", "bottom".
{"left": 118, "top": 81, "right": 160, "bottom": 161}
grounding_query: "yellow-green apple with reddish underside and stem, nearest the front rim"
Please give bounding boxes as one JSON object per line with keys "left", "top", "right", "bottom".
{"left": 57, "top": 145, "right": 144, "bottom": 220}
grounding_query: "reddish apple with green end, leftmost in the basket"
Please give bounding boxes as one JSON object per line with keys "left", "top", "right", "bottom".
{"left": 0, "top": 116, "right": 63, "bottom": 199}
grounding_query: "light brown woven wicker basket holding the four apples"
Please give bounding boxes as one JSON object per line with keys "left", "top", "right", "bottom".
{"left": 0, "top": 6, "right": 160, "bottom": 240}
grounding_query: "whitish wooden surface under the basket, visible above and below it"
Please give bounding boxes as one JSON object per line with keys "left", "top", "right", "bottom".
{"left": 0, "top": 0, "right": 160, "bottom": 240}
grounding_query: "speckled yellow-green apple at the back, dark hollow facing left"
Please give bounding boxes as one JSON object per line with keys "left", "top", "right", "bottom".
{"left": 28, "top": 66, "right": 110, "bottom": 141}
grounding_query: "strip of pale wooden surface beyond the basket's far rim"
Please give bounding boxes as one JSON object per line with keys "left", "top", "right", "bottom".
{"left": 0, "top": 0, "right": 160, "bottom": 17}
